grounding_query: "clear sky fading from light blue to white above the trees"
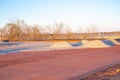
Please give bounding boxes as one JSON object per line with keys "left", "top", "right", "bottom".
{"left": 0, "top": 0, "right": 120, "bottom": 31}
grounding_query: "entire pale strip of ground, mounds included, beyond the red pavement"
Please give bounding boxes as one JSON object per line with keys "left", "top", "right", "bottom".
{"left": 0, "top": 40, "right": 120, "bottom": 54}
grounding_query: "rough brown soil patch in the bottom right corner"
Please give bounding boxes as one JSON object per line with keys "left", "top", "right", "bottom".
{"left": 80, "top": 64, "right": 120, "bottom": 80}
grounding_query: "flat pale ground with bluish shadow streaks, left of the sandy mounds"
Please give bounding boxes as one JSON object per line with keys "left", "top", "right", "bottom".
{"left": 0, "top": 42, "right": 52, "bottom": 54}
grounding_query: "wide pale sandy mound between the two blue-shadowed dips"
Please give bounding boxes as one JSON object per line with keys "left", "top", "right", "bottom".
{"left": 82, "top": 40, "right": 110, "bottom": 48}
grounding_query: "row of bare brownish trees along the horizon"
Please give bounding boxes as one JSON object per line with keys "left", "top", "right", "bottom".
{"left": 0, "top": 20, "right": 98, "bottom": 41}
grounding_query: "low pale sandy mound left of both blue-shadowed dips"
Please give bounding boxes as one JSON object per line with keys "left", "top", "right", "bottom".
{"left": 50, "top": 41, "right": 72, "bottom": 48}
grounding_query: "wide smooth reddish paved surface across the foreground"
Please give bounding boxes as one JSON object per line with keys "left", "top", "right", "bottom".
{"left": 0, "top": 46, "right": 120, "bottom": 80}
